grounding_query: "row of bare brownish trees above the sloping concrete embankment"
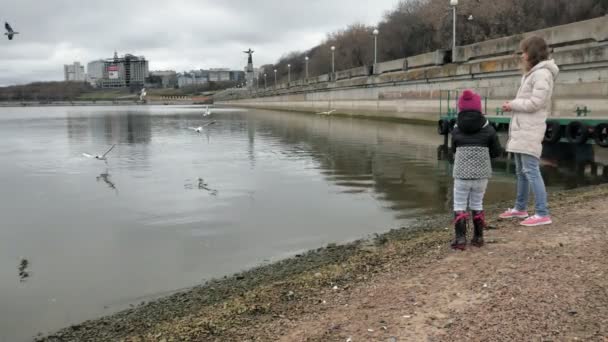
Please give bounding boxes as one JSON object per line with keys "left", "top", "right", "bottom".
{"left": 262, "top": 0, "right": 608, "bottom": 85}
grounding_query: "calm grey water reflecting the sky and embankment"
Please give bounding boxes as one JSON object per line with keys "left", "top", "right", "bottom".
{"left": 0, "top": 106, "right": 607, "bottom": 342}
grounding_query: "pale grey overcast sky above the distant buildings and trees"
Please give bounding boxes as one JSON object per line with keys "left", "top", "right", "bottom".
{"left": 0, "top": 0, "right": 398, "bottom": 85}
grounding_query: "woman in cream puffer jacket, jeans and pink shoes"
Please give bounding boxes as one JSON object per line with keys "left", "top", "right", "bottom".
{"left": 500, "top": 36, "right": 559, "bottom": 226}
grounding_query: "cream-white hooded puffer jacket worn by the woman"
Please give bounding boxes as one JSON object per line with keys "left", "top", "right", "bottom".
{"left": 507, "top": 59, "right": 559, "bottom": 158}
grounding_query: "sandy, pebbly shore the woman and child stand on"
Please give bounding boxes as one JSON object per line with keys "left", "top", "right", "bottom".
{"left": 39, "top": 186, "right": 608, "bottom": 341}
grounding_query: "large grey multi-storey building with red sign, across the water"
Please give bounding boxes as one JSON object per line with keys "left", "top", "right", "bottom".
{"left": 97, "top": 52, "right": 149, "bottom": 88}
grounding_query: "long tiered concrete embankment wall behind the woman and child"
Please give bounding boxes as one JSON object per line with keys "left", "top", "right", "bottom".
{"left": 215, "top": 16, "right": 608, "bottom": 121}
